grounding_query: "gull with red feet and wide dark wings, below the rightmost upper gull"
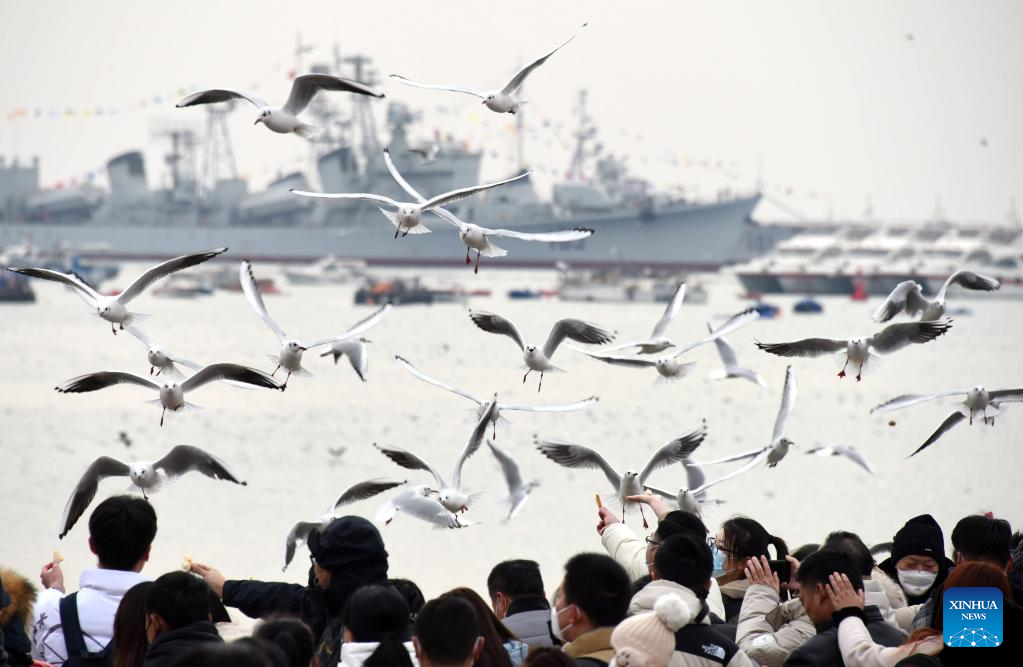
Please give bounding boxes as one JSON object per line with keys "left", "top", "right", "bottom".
{"left": 757, "top": 319, "right": 952, "bottom": 382}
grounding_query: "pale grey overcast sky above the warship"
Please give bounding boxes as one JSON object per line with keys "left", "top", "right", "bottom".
{"left": 0, "top": 0, "right": 1023, "bottom": 222}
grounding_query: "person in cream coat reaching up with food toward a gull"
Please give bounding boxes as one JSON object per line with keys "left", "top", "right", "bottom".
{"left": 596, "top": 493, "right": 725, "bottom": 621}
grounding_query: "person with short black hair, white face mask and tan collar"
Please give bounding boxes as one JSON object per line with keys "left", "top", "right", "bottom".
{"left": 550, "top": 553, "right": 630, "bottom": 667}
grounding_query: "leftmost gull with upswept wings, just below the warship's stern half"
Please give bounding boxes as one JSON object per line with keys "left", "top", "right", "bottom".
{"left": 7, "top": 248, "right": 227, "bottom": 334}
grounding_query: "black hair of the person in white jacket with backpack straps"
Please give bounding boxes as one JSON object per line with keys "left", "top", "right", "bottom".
{"left": 89, "top": 495, "right": 157, "bottom": 571}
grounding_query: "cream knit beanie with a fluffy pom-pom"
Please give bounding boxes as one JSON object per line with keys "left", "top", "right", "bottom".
{"left": 611, "top": 593, "right": 693, "bottom": 667}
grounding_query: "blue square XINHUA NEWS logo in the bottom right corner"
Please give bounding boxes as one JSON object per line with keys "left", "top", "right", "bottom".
{"left": 941, "top": 586, "right": 1004, "bottom": 648}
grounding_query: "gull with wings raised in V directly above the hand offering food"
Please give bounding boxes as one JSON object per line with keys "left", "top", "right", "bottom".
{"left": 534, "top": 423, "right": 707, "bottom": 528}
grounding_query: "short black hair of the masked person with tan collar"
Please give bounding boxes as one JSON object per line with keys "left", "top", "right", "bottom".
{"left": 562, "top": 553, "right": 631, "bottom": 626}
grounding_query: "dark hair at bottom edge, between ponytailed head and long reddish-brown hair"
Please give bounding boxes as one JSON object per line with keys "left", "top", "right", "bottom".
{"left": 412, "top": 595, "right": 480, "bottom": 665}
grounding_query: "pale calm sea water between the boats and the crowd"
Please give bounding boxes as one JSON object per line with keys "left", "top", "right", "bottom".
{"left": 0, "top": 266, "right": 1023, "bottom": 597}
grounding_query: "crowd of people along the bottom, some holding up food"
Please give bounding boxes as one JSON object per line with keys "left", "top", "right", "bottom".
{"left": 0, "top": 496, "right": 1023, "bottom": 667}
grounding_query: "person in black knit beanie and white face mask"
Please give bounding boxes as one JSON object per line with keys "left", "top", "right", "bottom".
{"left": 878, "top": 515, "right": 954, "bottom": 629}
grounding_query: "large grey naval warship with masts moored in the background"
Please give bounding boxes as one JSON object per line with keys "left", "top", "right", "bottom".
{"left": 0, "top": 56, "right": 795, "bottom": 271}
